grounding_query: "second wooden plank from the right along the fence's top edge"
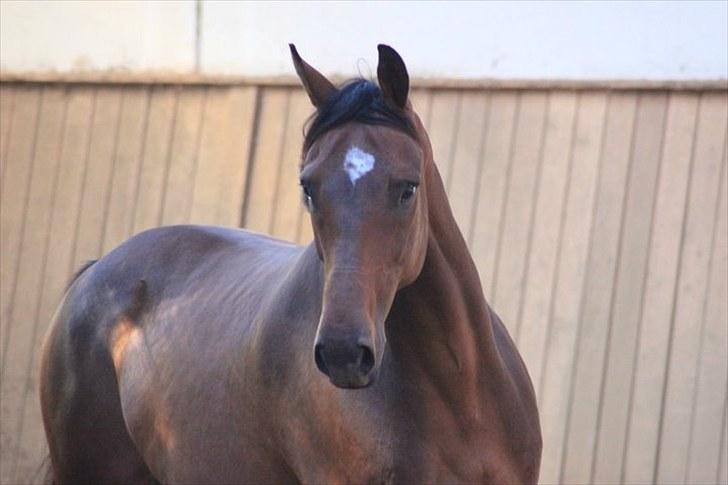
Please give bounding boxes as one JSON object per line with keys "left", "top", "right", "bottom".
{"left": 620, "top": 94, "right": 697, "bottom": 483}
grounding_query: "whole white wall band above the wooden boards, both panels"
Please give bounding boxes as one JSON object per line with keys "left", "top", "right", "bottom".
{"left": 0, "top": 1, "right": 728, "bottom": 79}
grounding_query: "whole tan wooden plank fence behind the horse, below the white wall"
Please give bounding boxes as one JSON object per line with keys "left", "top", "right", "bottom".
{"left": 0, "top": 82, "right": 728, "bottom": 483}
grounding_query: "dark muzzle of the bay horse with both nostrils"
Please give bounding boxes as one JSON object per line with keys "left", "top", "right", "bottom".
{"left": 314, "top": 338, "right": 374, "bottom": 389}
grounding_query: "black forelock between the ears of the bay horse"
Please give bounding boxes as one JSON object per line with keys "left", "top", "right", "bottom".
{"left": 303, "top": 79, "right": 416, "bottom": 153}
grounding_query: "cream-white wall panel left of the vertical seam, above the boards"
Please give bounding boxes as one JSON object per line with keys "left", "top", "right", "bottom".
{"left": 0, "top": 0, "right": 195, "bottom": 71}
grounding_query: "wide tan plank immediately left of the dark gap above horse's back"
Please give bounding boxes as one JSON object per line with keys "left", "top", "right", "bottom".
{"left": 190, "top": 87, "right": 257, "bottom": 226}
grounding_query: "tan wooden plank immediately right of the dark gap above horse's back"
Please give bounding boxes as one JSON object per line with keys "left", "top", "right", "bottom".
{"left": 245, "top": 89, "right": 291, "bottom": 233}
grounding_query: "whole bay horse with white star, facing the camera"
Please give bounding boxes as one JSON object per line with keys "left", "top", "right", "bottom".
{"left": 40, "top": 45, "right": 541, "bottom": 484}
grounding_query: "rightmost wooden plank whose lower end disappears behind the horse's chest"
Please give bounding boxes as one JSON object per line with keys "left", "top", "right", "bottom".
{"left": 513, "top": 92, "right": 577, "bottom": 398}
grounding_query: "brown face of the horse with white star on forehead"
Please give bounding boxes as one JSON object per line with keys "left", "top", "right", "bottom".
{"left": 294, "top": 47, "right": 428, "bottom": 388}
